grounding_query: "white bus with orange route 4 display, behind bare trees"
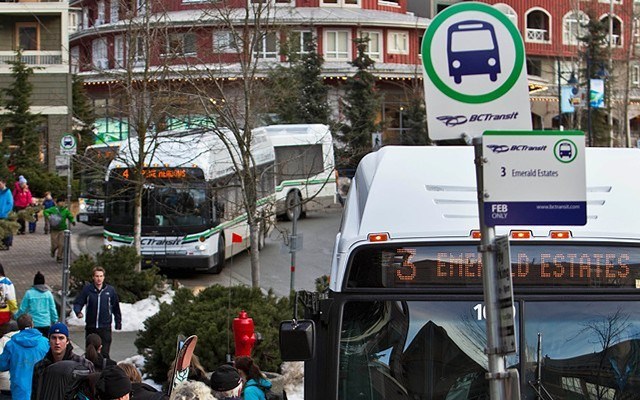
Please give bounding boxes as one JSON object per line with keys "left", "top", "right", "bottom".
{"left": 104, "top": 129, "right": 275, "bottom": 273}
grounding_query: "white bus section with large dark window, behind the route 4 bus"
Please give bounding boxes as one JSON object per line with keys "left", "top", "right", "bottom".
{"left": 254, "top": 124, "right": 336, "bottom": 220}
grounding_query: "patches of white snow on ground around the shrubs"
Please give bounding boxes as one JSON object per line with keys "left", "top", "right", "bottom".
{"left": 67, "top": 289, "right": 304, "bottom": 400}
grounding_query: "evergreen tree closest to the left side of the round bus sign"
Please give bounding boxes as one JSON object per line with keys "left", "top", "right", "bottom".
{"left": 336, "top": 38, "right": 380, "bottom": 168}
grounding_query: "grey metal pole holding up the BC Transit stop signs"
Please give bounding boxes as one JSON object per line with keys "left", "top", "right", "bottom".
{"left": 473, "top": 137, "right": 509, "bottom": 400}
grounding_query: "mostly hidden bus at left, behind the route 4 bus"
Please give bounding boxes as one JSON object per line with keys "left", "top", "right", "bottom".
{"left": 78, "top": 142, "right": 120, "bottom": 226}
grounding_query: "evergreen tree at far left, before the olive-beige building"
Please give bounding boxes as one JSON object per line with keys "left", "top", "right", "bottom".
{"left": 1, "top": 50, "right": 41, "bottom": 171}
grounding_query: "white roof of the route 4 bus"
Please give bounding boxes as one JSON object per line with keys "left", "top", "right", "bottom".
{"left": 107, "top": 129, "right": 275, "bottom": 180}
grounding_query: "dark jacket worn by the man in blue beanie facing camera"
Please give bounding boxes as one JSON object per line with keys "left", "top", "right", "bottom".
{"left": 31, "top": 343, "right": 94, "bottom": 400}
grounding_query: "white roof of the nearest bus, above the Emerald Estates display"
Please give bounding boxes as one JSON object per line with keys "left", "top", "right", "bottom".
{"left": 336, "top": 146, "right": 640, "bottom": 264}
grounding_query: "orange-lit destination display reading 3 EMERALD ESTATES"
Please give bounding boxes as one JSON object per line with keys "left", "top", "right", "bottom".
{"left": 348, "top": 245, "right": 640, "bottom": 288}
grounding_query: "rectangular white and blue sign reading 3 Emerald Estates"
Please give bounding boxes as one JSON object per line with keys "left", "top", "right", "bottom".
{"left": 482, "top": 131, "right": 587, "bottom": 226}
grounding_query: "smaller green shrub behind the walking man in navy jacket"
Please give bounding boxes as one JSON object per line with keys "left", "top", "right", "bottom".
{"left": 70, "top": 246, "right": 164, "bottom": 303}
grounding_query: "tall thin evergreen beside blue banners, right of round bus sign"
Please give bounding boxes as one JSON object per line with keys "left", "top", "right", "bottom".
{"left": 578, "top": 12, "right": 609, "bottom": 146}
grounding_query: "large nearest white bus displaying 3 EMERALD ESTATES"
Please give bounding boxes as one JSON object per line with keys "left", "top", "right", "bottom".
{"left": 281, "top": 146, "right": 640, "bottom": 400}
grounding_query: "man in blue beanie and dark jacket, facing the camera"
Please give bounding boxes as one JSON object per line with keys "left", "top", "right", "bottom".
{"left": 31, "top": 322, "right": 94, "bottom": 400}
